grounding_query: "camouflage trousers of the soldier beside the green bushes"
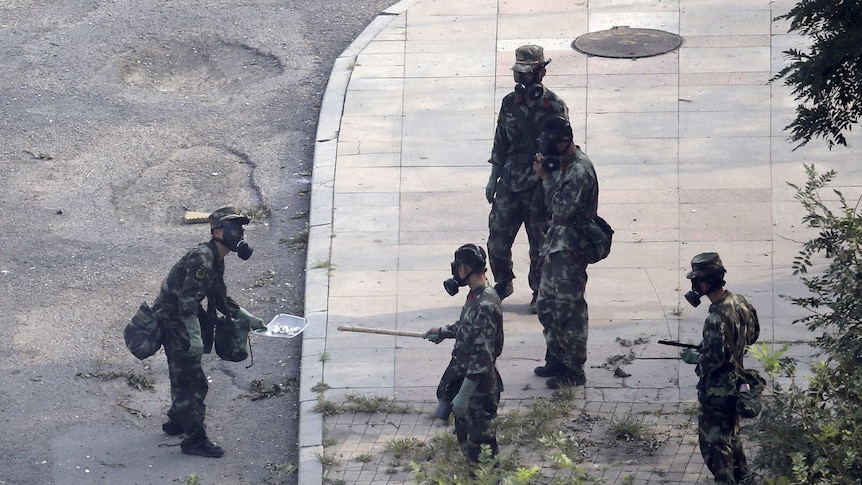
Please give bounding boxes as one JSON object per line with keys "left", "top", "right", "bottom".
{"left": 697, "top": 390, "right": 748, "bottom": 484}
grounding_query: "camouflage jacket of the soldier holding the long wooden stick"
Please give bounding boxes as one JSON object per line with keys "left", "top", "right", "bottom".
{"left": 437, "top": 281, "right": 503, "bottom": 401}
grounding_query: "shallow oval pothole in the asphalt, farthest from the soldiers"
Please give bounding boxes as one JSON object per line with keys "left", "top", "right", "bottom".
{"left": 120, "top": 39, "right": 283, "bottom": 92}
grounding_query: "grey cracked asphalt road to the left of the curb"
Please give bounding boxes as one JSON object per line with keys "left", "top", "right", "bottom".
{"left": 0, "top": 0, "right": 394, "bottom": 485}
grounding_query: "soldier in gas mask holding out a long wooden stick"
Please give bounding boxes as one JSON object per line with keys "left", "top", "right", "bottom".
{"left": 424, "top": 244, "right": 503, "bottom": 464}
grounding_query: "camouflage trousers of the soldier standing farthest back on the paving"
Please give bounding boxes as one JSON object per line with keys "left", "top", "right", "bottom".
{"left": 488, "top": 183, "right": 550, "bottom": 293}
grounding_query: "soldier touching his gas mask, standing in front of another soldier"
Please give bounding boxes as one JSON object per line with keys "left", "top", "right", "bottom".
{"left": 533, "top": 117, "right": 599, "bottom": 389}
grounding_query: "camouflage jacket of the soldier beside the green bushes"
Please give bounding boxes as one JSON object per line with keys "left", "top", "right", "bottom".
{"left": 696, "top": 291, "right": 760, "bottom": 393}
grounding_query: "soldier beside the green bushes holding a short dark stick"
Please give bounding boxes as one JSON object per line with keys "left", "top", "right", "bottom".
{"left": 682, "top": 253, "right": 760, "bottom": 485}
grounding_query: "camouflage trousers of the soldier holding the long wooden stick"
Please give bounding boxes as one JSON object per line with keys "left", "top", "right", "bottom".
{"left": 455, "top": 392, "right": 500, "bottom": 463}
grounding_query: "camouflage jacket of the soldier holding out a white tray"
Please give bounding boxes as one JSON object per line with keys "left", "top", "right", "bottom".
{"left": 153, "top": 240, "right": 239, "bottom": 322}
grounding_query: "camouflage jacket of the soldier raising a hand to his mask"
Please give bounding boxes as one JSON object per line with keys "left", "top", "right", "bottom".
{"left": 541, "top": 146, "right": 599, "bottom": 256}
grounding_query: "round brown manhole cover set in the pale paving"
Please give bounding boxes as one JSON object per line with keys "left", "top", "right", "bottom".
{"left": 572, "top": 26, "right": 682, "bottom": 58}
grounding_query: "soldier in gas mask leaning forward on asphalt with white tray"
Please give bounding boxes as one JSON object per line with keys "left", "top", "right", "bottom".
{"left": 153, "top": 207, "right": 266, "bottom": 458}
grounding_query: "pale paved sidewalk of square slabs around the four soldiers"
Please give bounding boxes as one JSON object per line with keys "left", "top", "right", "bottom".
{"left": 299, "top": 0, "right": 862, "bottom": 485}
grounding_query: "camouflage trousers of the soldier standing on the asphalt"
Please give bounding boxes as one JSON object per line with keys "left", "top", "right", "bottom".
{"left": 162, "top": 322, "right": 209, "bottom": 442}
